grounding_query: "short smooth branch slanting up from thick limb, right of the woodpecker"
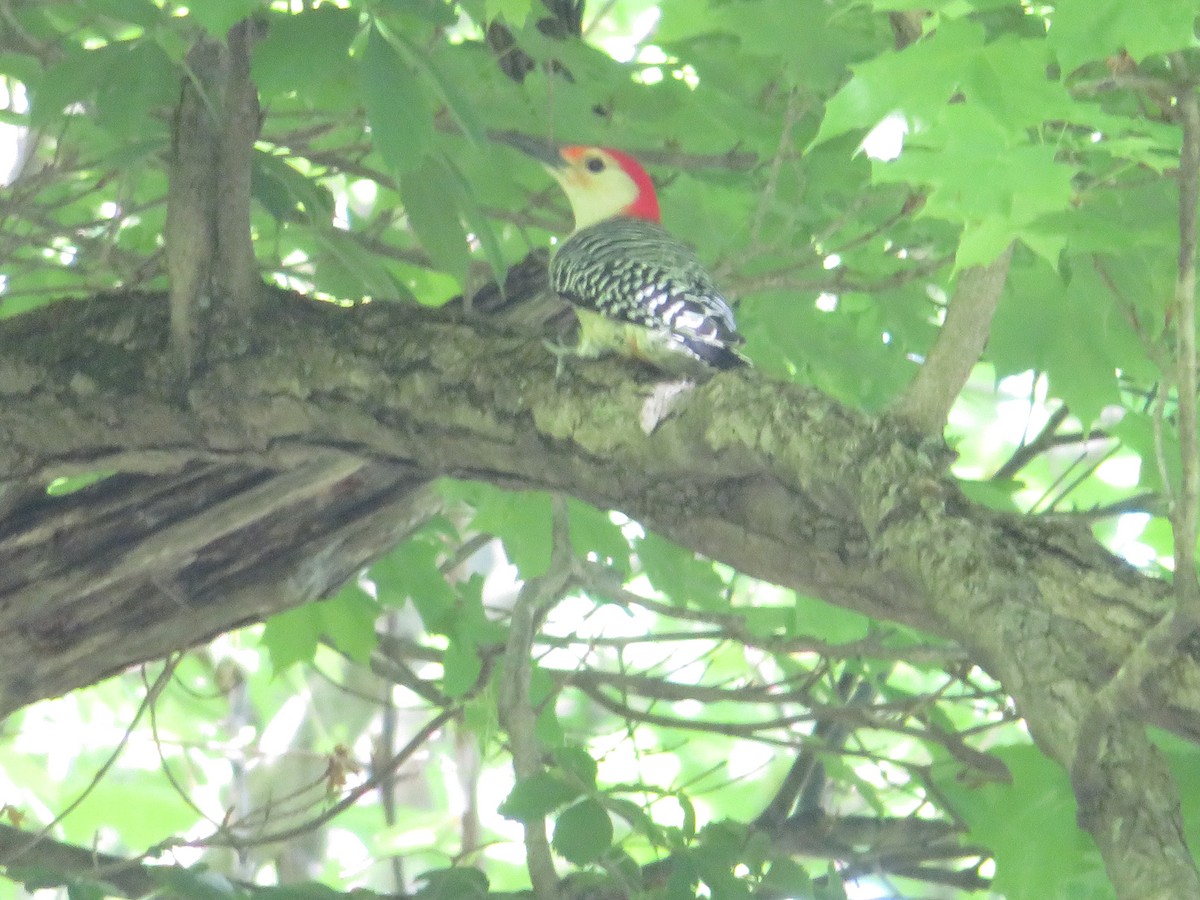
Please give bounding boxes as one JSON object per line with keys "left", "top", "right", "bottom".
{"left": 893, "top": 244, "right": 1013, "bottom": 437}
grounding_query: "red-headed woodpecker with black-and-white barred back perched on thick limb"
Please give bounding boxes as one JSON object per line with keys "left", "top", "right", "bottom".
{"left": 497, "top": 132, "right": 746, "bottom": 374}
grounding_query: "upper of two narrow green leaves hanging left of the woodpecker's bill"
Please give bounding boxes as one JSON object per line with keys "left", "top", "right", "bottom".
{"left": 360, "top": 26, "right": 433, "bottom": 175}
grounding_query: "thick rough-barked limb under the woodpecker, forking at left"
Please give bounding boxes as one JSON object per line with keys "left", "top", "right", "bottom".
{"left": 0, "top": 296, "right": 1200, "bottom": 898}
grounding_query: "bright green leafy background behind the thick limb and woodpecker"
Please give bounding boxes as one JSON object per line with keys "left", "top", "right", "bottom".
{"left": 0, "top": 0, "right": 1200, "bottom": 900}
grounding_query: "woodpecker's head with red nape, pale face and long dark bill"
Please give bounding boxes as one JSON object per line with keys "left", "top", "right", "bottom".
{"left": 498, "top": 132, "right": 660, "bottom": 230}
